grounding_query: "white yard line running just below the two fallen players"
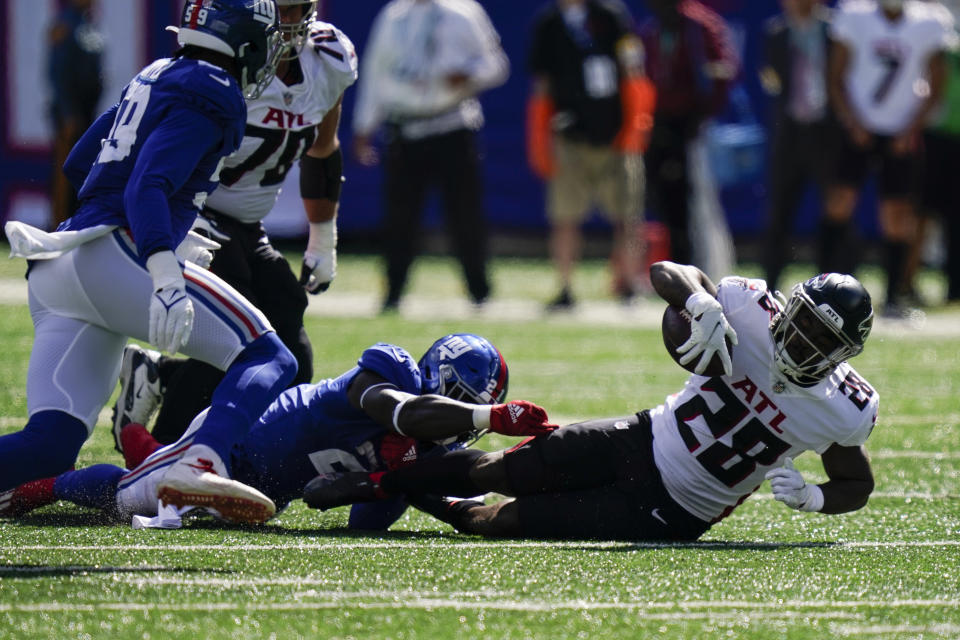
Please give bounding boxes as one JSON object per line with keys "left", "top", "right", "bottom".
{"left": 0, "top": 539, "right": 960, "bottom": 556}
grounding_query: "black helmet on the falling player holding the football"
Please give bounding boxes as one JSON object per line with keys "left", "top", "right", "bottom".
{"left": 770, "top": 273, "right": 873, "bottom": 387}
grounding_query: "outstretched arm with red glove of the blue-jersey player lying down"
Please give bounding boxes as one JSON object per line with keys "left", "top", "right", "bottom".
{"left": 347, "top": 371, "right": 556, "bottom": 440}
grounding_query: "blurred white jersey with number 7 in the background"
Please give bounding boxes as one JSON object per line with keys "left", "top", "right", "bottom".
{"left": 831, "top": 0, "right": 956, "bottom": 135}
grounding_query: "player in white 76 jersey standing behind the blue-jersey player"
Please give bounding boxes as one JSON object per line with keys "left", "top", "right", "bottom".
{"left": 113, "top": 0, "right": 357, "bottom": 449}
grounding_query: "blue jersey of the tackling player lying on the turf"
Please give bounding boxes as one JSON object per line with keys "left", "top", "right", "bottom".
{"left": 233, "top": 342, "right": 422, "bottom": 506}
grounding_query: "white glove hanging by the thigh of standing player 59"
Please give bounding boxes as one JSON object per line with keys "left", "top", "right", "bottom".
{"left": 147, "top": 251, "right": 193, "bottom": 354}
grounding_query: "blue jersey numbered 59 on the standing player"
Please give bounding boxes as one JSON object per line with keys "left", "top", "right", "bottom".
{"left": 60, "top": 58, "right": 247, "bottom": 260}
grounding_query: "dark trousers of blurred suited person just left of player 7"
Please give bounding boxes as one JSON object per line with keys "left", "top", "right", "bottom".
{"left": 763, "top": 117, "right": 836, "bottom": 289}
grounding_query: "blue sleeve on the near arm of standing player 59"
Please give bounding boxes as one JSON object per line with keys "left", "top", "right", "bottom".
{"left": 123, "top": 109, "right": 223, "bottom": 257}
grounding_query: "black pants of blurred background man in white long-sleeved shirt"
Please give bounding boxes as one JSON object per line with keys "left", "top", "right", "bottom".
{"left": 382, "top": 129, "right": 490, "bottom": 307}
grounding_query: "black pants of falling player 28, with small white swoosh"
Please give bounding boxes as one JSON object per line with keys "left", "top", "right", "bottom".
{"left": 504, "top": 411, "right": 710, "bottom": 541}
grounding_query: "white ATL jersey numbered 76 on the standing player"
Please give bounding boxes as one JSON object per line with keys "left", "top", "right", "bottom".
{"left": 206, "top": 21, "right": 357, "bottom": 222}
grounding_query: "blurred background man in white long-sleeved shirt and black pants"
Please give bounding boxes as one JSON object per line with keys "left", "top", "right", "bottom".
{"left": 353, "top": 0, "right": 509, "bottom": 311}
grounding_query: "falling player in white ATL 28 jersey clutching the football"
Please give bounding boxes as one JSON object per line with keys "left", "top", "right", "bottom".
{"left": 304, "top": 262, "right": 878, "bottom": 540}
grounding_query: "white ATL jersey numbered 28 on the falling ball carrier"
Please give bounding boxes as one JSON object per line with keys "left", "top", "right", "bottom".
{"left": 651, "top": 277, "right": 878, "bottom": 522}
